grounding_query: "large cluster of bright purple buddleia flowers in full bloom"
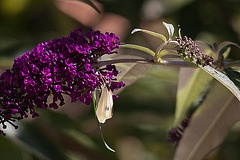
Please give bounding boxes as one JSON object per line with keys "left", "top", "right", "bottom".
{"left": 0, "top": 28, "right": 124, "bottom": 135}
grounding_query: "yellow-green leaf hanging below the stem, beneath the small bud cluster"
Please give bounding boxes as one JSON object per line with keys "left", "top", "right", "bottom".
{"left": 175, "top": 68, "right": 213, "bottom": 125}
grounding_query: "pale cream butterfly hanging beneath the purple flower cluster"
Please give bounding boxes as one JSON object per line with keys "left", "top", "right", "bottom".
{"left": 96, "top": 84, "right": 113, "bottom": 123}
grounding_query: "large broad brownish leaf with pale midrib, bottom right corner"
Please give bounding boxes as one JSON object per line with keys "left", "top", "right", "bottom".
{"left": 174, "top": 83, "right": 240, "bottom": 160}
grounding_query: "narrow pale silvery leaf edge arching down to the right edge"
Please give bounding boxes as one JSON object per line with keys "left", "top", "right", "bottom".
{"left": 198, "top": 65, "right": 240, "bottom": 101}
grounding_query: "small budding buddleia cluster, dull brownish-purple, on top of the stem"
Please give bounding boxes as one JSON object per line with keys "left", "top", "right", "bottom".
{"left": 176, "top": 36, "right": 214, "bottom": 66}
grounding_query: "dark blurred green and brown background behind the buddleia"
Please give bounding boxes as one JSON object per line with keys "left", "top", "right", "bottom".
{"left": 0, "top": 0, "right": 240, "bottom": 160}
